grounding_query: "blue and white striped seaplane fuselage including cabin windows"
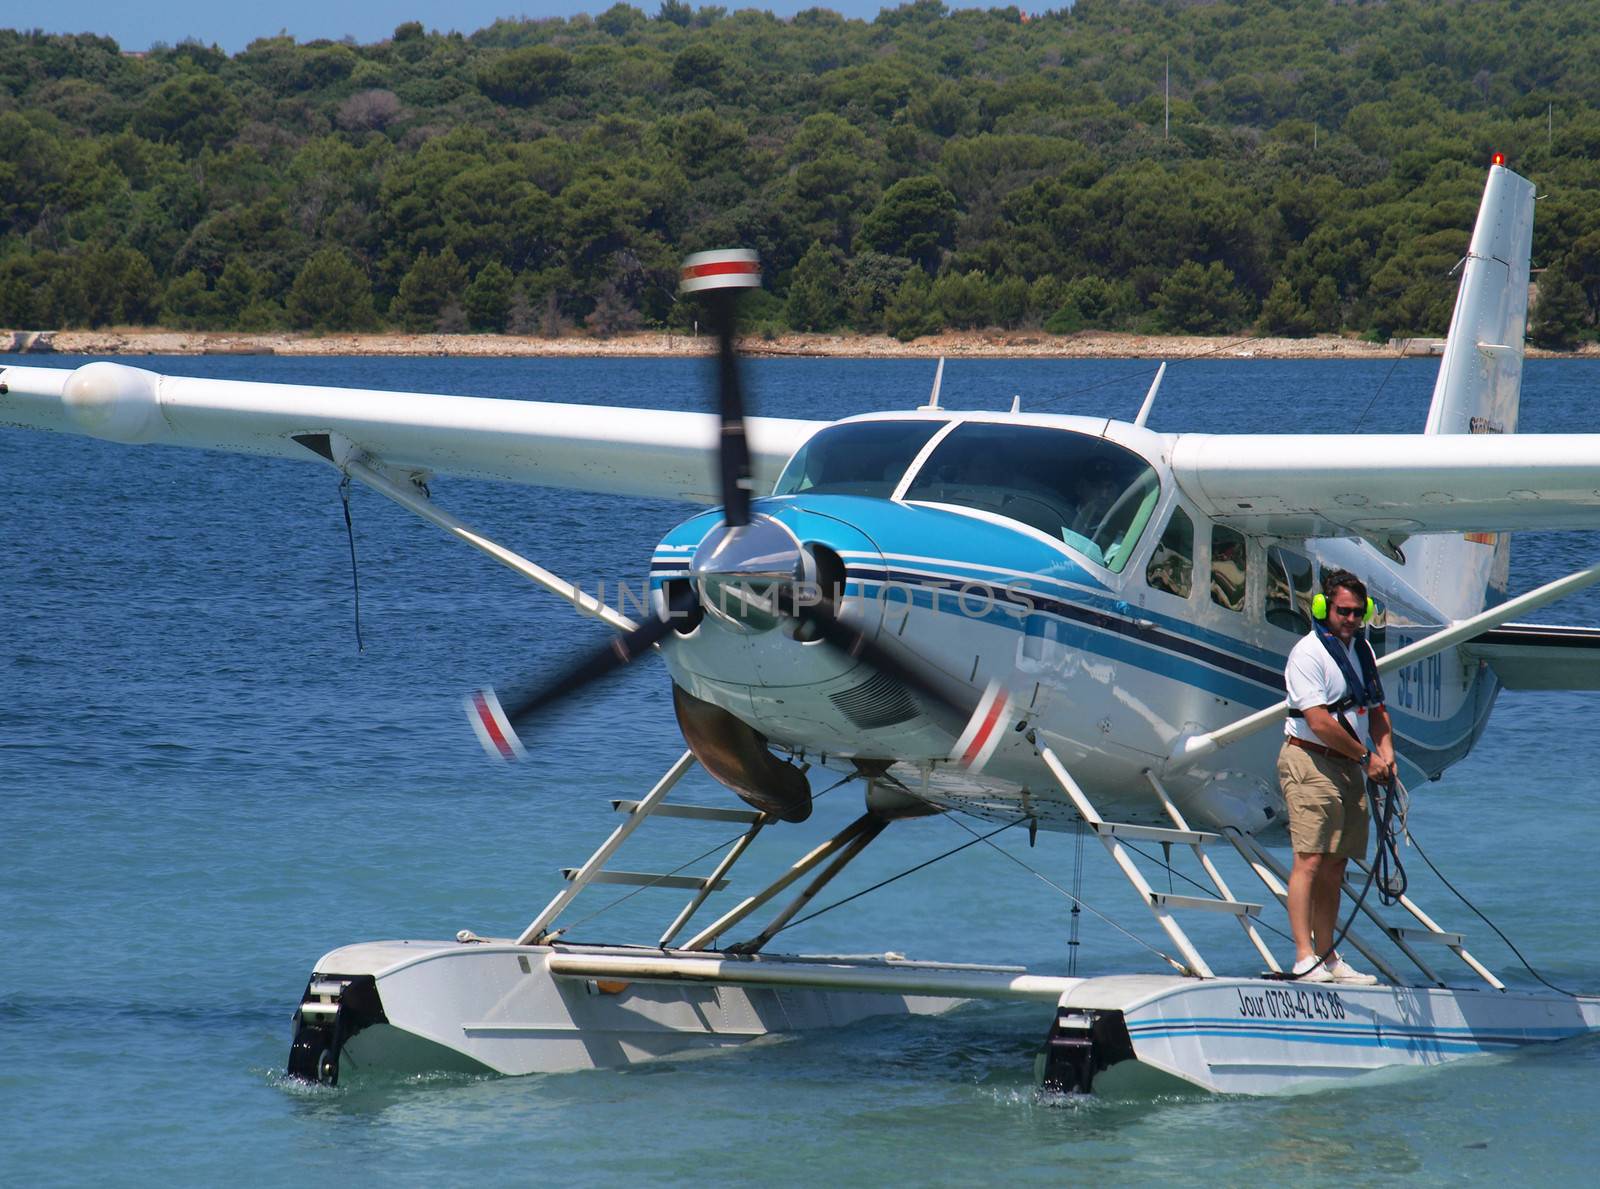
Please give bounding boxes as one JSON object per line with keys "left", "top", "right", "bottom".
{"left": 651, "top": 411, "right": 1498, "bottom": 832}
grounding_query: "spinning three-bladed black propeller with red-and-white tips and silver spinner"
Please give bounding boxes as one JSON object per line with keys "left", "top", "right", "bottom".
{"left": 466, "top": 250, "right": 1011, "bottom": 768}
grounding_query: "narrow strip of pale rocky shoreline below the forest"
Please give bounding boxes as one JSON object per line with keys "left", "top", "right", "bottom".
{"left": 0, "top": 328, "right": 1600, "bottom": 358}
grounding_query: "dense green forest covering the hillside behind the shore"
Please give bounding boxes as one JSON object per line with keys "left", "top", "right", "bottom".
{"left": 0, "top": 0, "right": 1600, "bottom": 346}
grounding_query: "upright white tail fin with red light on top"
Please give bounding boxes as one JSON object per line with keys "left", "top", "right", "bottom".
{"left": 1406, "top": 165, "right": 1534, "bottom": 619}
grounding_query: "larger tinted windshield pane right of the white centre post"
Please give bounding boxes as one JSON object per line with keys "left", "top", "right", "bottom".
{"left": 906, "top": 421, "right": 1162, "bottom": 571}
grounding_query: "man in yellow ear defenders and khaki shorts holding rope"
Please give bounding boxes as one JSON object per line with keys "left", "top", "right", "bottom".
{"left": 1278, "top": 570, "right": 1395, "bottom": 984}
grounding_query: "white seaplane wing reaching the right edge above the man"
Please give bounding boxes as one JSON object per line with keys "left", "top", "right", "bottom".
{"left": 1171, "top": 434, "right": 1600, "bottom": 539}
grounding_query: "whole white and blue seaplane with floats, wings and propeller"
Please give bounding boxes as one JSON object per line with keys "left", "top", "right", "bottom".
{"left": 0, "top": 157, "right": 1600, "bottom": 1095}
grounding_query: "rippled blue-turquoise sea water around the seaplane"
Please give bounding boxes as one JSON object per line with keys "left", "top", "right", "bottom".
{"left": 0, "top": 357, "right": 1600, "bottom": 1184}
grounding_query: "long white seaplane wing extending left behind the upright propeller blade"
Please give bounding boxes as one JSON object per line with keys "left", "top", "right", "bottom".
{"left": 0, "top": 362, "right": 827, "bottom": 504}
